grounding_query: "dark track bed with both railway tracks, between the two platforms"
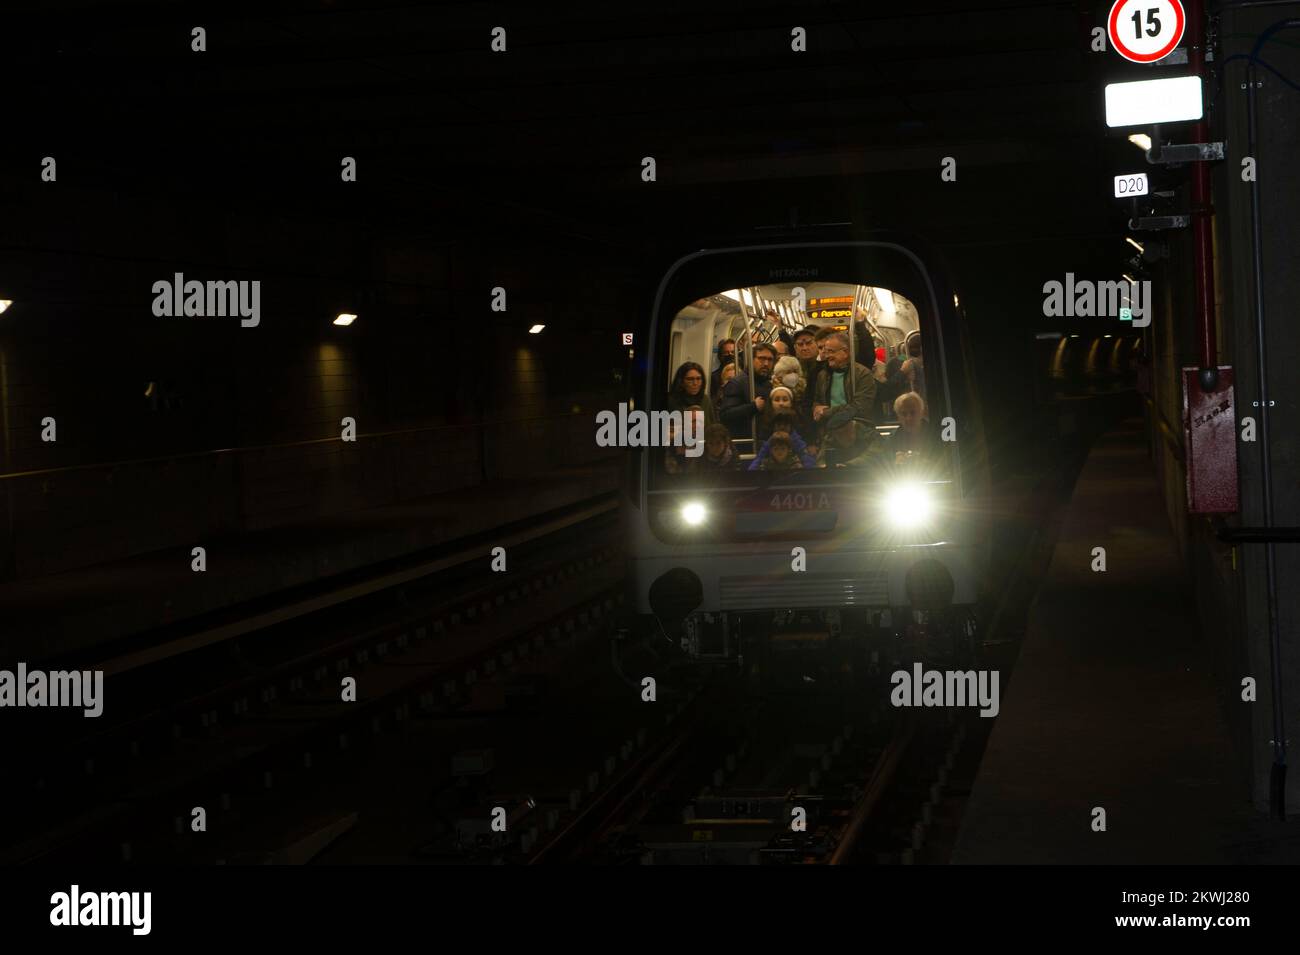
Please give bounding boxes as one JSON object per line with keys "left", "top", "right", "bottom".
{"left": 0, "top": 426, "right": 1081, "bottom": 865}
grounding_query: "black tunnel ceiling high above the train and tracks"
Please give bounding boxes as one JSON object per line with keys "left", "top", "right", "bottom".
{"left": 3, "top": 0, "right": 1113, "bottom": 246}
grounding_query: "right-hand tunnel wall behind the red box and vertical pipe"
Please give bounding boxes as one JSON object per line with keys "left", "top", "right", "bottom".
{"left": 1148, "top": 3, "right": 1300, "bottom": 812}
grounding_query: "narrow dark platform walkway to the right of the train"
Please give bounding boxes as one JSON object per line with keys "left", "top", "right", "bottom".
{"left": 950, "top": 420, "right": 1300, "bottom": 864}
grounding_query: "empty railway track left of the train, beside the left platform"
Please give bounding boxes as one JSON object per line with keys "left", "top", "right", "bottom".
{"left": 0, "top": 516, "right": 620, "bottom": 864}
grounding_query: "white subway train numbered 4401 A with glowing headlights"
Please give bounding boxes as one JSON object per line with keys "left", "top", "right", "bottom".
{"left": 619, "top": 234, "right": 989, "bottom": 667}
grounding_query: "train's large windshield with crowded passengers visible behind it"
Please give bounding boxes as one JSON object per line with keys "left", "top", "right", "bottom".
{"left": 647, "top": 282, "right": 945, "bottom": 490}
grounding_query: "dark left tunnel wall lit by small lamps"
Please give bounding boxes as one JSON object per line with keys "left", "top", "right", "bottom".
{"left": 0, "top": 186, "right": 621, "bottom": 579}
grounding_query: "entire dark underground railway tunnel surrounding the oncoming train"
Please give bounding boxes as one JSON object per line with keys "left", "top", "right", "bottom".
{"left": 0, "top": 0, "right": 1300, "bottom": 925}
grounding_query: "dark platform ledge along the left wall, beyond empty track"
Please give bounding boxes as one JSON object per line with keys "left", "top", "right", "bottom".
{"left": 0, "top": 456, "right": 623, "bottom": 672}
